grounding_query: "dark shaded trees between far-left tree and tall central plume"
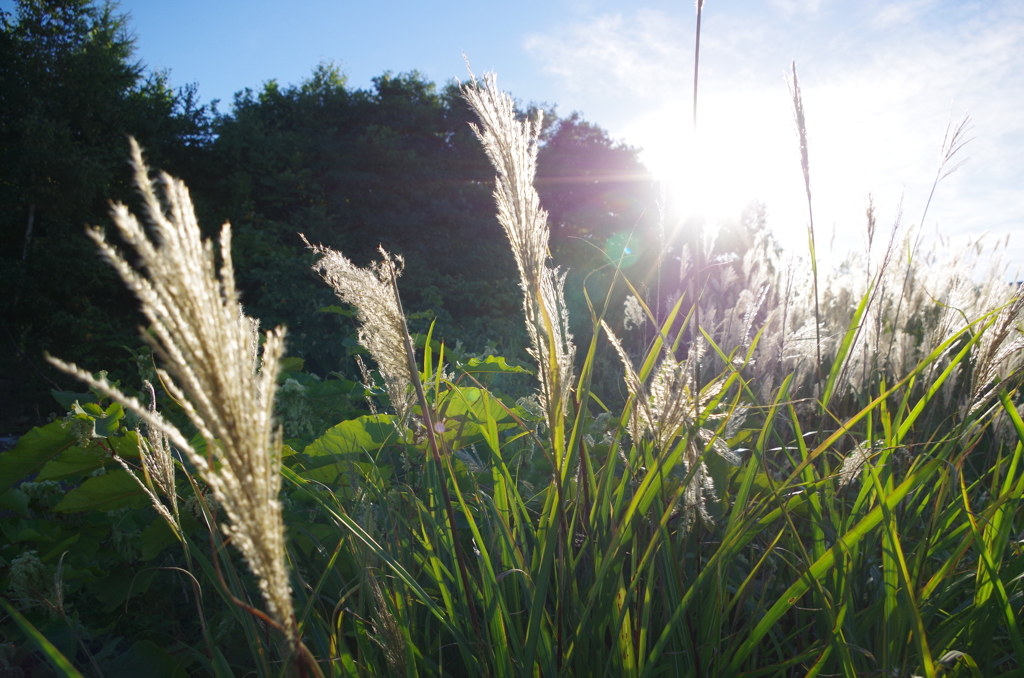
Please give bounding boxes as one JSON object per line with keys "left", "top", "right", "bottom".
{"left": 206, "top": 65, "right": 519, "bottom": 373}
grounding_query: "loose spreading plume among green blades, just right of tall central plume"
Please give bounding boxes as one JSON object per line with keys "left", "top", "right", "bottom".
{"left": 601, "top": 321, "right": 745, "bottom": 524}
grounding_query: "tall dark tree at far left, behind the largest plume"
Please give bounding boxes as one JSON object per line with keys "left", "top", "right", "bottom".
{"left": 0, "top": 0, "right": 206, "bottom": 428}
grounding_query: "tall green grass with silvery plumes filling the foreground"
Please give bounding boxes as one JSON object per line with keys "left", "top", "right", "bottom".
{"left": 37, "top": 35, "right": 1024, "bottom": 678}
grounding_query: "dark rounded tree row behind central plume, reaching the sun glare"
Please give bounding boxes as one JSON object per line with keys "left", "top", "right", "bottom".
{"left": 207, "top": 72, "right": 656, "bottom": 385}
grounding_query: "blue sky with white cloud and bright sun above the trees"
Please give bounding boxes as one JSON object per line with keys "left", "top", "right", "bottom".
{"left": 8, "top": 0, "right": 1024, "bottom": 270}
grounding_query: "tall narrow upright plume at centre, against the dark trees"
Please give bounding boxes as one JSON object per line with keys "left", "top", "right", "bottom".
{"left": 462, "top": 73, "right": 575, "bottom": 429}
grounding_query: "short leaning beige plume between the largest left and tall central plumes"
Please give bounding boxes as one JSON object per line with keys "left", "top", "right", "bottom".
{"left": 302, "top": 236, "right": 419, "bottom": 424}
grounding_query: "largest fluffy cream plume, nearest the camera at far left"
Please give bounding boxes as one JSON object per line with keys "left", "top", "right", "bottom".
{"left": 50, "top": 139, "right": 297, "bottom": 642}
